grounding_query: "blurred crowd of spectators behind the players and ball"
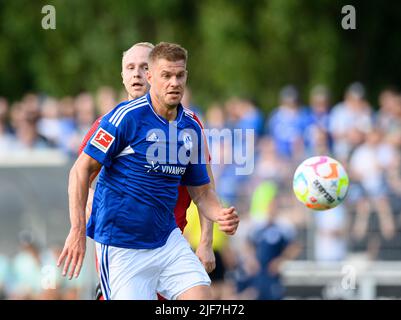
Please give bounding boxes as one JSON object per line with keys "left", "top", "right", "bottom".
{"left": 0, "top": 83, "right": 401, "bottom": 299}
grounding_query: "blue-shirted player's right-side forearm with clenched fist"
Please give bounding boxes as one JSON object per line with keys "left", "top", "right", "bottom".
{"left": 187, "top": 182, "right": 239, "bottom": 235}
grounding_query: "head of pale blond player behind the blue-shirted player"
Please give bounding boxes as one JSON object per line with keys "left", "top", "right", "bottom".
{"left": 121, "top": 46, "right": 151, "bottom": 99}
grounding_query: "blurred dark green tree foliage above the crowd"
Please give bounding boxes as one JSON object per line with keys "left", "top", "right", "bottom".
{"left": 0, "top": 0, "right": 401, "bottom": 111}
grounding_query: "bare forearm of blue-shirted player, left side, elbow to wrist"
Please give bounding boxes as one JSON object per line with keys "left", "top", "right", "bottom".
{"left": 68, "top": 164, "right": 90, "bottom": 232}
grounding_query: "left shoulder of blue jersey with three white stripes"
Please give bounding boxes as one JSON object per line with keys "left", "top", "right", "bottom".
{"left": 104, "top": 95, "right": 149, "bottom": 127}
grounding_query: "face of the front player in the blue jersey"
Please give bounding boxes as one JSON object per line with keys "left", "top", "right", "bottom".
{"left": 147, "top": 59, "right": 187, "bottom": 107}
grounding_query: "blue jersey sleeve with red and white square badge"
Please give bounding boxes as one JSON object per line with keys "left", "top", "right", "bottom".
{"left": 84, "top": 109, "right": 136, "bottom": 167}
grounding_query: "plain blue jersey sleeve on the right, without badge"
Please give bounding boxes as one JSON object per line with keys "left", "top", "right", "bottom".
{"left": 181, "top": 120, "right": 210, "bottom": 186}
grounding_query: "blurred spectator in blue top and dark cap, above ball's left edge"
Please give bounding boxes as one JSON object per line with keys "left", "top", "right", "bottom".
{"left": 266, "top": 86, "right": 306, "bottom": 159}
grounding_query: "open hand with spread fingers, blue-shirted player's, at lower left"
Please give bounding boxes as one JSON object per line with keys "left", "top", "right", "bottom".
{"left": 57, "top": 229, "right": 86, "bottom": 280}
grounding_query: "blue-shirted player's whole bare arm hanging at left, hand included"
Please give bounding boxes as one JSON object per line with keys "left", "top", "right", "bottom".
{"left": 57, "top": 153, "right": 101, "bottom": 279}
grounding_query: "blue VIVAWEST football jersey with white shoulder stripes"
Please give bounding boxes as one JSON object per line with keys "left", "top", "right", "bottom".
{"left": 84, "top": 94, "right": 210, "bottom": 249}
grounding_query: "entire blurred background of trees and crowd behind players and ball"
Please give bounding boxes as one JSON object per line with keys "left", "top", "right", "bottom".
{"left": 0, "top": 0, "right": 401, "bottom": 299}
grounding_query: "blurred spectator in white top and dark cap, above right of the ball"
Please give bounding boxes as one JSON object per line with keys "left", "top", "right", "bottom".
{"left": 330, "top": 82, "right": 373, "bottom": 162}
